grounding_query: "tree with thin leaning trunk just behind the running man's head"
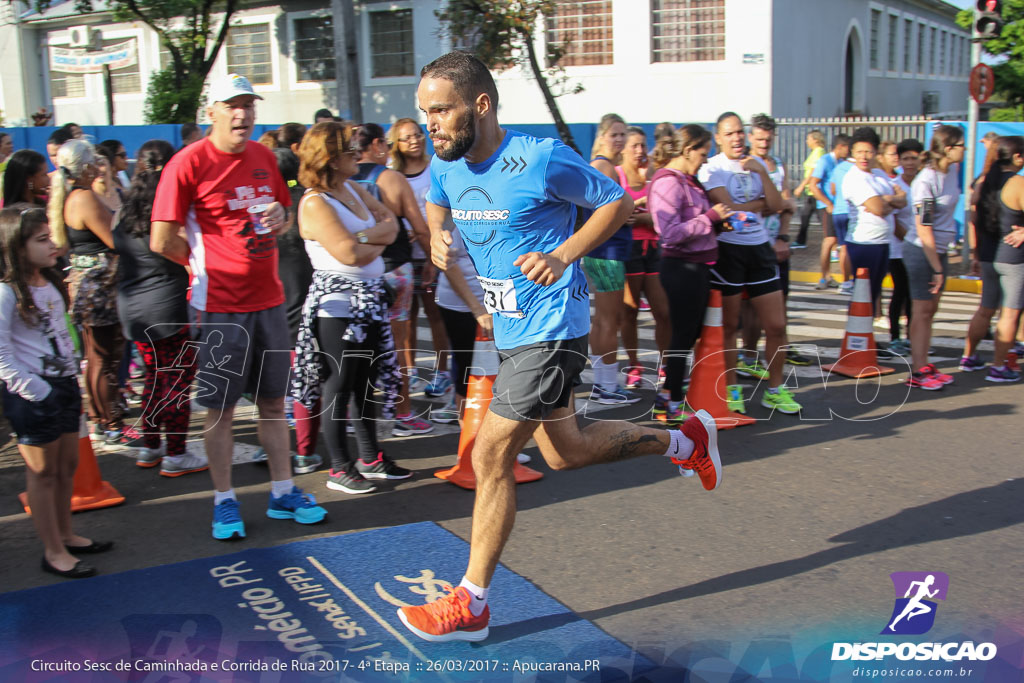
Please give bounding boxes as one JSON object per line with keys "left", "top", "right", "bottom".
{"left": 434, "top": 0, "right": 583, "bottom": 152}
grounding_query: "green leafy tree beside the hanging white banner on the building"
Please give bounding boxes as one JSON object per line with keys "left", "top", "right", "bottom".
{"left": 36, "top": 0, "right": 240, "bottom": 123}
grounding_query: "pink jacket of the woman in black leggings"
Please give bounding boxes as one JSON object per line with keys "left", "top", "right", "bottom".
{"left": 647, "top": 168, "right": 722, "bottom": 263}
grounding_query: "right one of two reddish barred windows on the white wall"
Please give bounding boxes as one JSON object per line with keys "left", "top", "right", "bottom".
{"left": 650, "top": 0, "right": 725, "bottom": 61}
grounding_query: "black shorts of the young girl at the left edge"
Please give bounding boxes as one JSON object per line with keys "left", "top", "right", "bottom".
{"left": 0, "top": 377, "right": 82, "bottom": 445}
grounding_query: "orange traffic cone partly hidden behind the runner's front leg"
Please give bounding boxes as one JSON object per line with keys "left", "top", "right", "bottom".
{"left": 434, "top": 328, "right": 544, "bottom": 489}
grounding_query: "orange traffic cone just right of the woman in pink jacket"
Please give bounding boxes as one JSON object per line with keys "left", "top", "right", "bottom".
{"left": 686, "top": 290, "right": 757, "bottom": 429}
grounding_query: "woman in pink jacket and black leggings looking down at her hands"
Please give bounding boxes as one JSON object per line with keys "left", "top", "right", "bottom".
{"left": 647, "top": 124, "right": 732, "bottom": 423}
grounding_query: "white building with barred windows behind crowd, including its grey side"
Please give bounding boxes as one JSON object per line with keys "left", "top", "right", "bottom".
{"left": 0, "top": 0, "right": 970, "bottom": 125}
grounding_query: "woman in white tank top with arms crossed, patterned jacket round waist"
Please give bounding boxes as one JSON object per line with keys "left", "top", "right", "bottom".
{"left": 291, "top": 122, "right": 412, "bottom": 494}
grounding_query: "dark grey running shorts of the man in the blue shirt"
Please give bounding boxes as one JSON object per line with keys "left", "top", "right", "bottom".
{"left": 490, "top": 335, "right": 589, "bottom": 422}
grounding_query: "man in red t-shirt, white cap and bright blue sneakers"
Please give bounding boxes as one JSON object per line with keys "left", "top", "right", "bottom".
{"left": 151, "top": 74, "right": 327, "bottom": 540}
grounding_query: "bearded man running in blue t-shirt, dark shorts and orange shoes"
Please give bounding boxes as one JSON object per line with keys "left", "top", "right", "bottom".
{"left": 398, "top": 52, "right": 722, "bottom": 642}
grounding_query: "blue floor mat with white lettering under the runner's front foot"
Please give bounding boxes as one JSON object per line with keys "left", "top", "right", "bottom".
{"left": 0, "top": 522, "right": 653, "bottom": 683}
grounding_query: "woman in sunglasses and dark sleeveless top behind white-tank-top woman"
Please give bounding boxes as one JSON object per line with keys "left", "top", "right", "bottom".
{"left": 352, "top": 123, "right": 434, "bottom": 436}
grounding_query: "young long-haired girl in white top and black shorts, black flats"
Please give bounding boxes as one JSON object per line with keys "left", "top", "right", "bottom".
{"left": 0, "top": 204, "right": 114, "bottom": 579}
